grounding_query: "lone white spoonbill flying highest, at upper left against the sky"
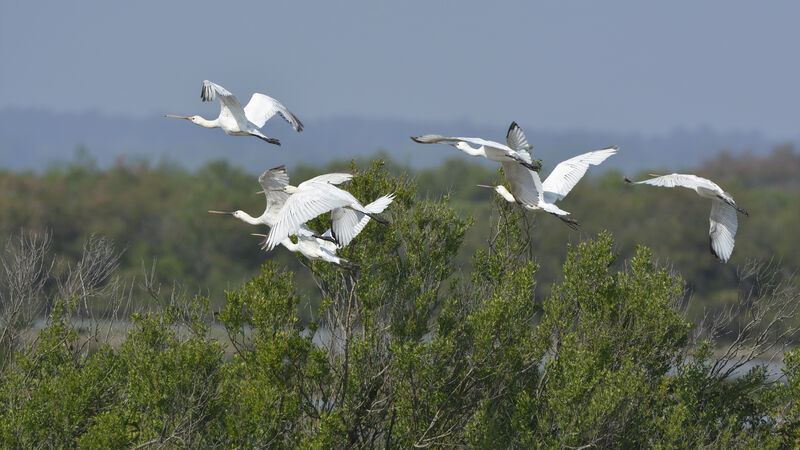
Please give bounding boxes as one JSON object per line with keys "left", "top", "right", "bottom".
{"left": 166, "top": 80, "right": 303, "bottom": 145}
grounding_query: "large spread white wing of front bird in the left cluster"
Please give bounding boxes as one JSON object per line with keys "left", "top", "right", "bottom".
{"left": 265, "top": 185, "right": 354, "bottom": 250}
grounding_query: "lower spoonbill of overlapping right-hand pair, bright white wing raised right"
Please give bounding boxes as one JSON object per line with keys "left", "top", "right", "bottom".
{"left": 478, "top": 123, "right": 617, "bottom": 229}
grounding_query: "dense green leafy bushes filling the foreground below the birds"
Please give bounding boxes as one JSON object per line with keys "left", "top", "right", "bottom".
{"left": 0, "top": 164, "right": 800, "bottom": 448}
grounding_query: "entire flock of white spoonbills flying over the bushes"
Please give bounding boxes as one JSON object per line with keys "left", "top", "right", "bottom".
{"left": 166, "top": 80, "right": 748, "bottom": 268}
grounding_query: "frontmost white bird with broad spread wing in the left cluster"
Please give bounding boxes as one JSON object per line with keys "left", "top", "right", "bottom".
{"left": 264, "top": 173, "right": 394, "bottom": 250}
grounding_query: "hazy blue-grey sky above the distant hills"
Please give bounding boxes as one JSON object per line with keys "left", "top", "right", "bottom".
{"left": 0, "top": 0, "right": 800, "bottom": 139}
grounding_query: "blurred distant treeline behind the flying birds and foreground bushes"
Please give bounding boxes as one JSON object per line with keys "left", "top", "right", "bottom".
{"left": 0, "top": 146, "right": 800, "bottom": 313}
